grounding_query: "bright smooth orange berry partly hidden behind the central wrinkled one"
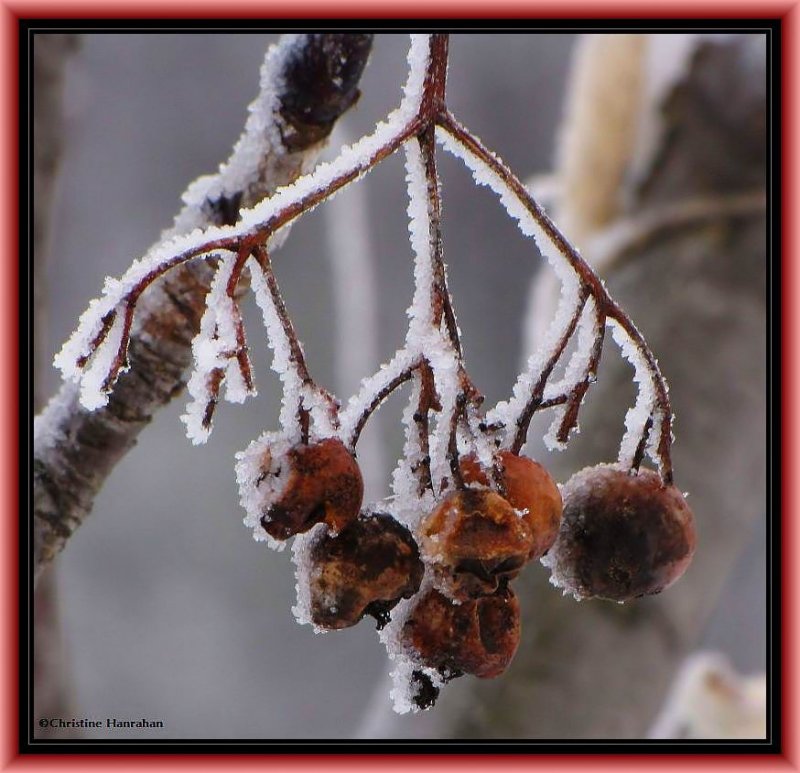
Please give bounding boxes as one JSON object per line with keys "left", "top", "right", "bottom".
{"left": 461, "top": 451, "right": 562, "bottom": 561}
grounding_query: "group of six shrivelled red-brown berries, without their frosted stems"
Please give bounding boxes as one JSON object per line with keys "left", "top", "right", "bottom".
{"left": 248, "top": 438, "right": 696, "bottom": 709}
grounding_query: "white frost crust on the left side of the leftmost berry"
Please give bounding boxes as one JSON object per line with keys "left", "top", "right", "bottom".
{"left": 236, "top": 432, "right": 295, "bottom": 550}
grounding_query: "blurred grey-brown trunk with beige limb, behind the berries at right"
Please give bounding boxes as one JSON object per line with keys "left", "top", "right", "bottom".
{"left": 361, "top": 35, "right": 770, "bottom": 739}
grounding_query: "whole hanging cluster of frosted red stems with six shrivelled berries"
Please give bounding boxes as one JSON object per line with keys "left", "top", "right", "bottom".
{"left": 57, "top": 34, "right": 695, "bottom": 711}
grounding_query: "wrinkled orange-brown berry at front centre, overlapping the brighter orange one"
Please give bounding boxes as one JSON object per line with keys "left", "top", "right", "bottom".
{"left": 420, "top": 489, "right": 533, "bottom": 601}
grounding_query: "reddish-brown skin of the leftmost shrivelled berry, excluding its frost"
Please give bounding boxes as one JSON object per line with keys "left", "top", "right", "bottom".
{"left": 261, "top": 438, "right": 364, "bottom": 540}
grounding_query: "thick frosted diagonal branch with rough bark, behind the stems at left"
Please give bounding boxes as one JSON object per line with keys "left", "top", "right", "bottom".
{"left": 33, "top": 34, "right": 372, "bottom": 577}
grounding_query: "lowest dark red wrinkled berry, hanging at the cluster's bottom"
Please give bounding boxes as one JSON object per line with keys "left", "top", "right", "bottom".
{"left": 402, "top": 587, "right": 520, "bottom": 679}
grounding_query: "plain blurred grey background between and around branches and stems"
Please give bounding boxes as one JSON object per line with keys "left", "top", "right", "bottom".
{"left": 42, "top": 34, "right": 765, "bottom": 738}
